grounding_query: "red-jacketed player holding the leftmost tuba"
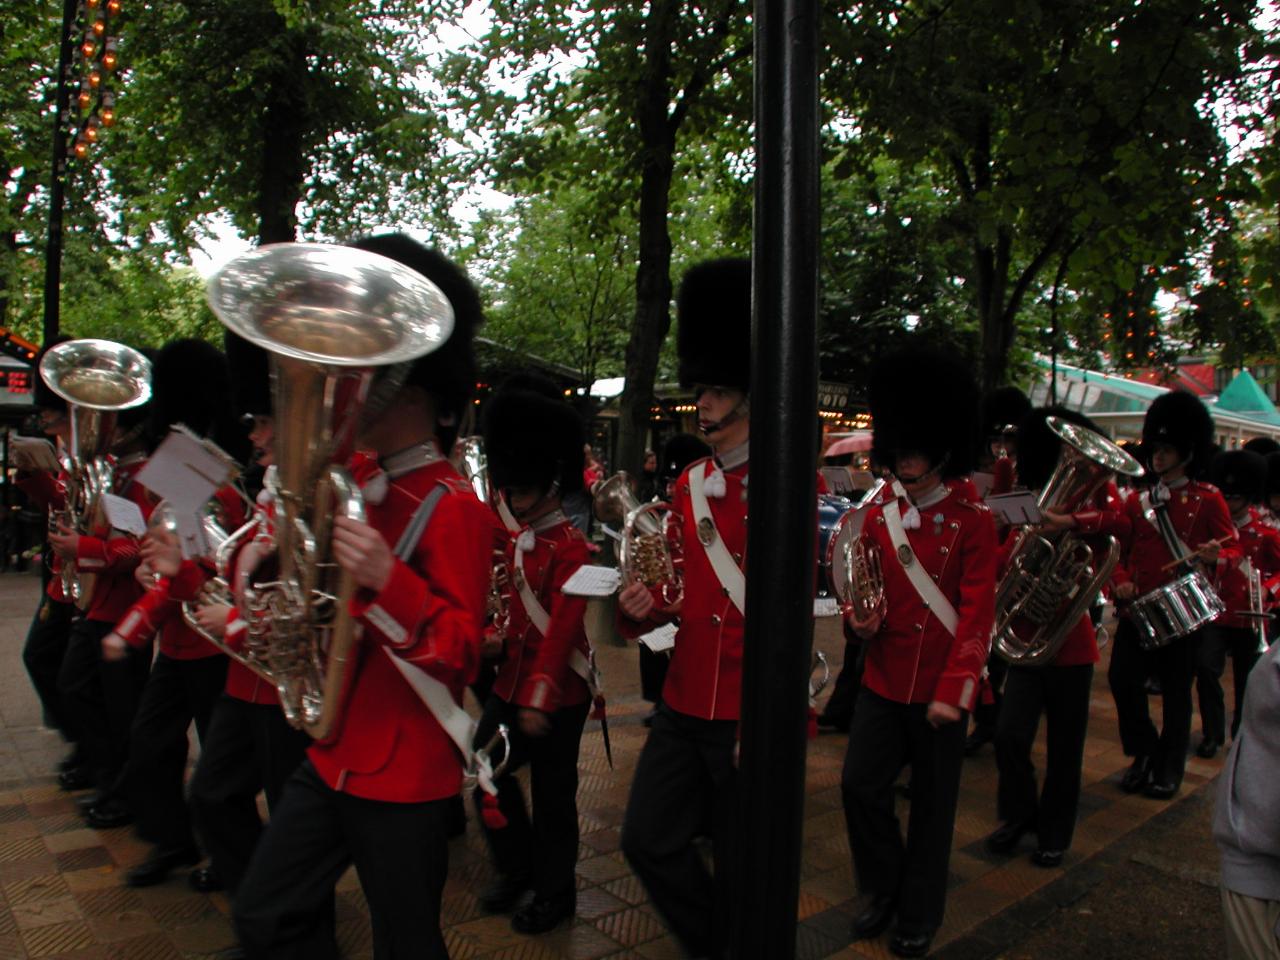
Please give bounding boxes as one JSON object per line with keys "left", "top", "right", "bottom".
{"left": 49, "top": 355, "right": 156, "bottom": 829}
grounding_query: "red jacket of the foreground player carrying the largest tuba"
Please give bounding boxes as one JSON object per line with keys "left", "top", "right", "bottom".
{"left": 307, "top": 461, "right": 493, "bottom": 803}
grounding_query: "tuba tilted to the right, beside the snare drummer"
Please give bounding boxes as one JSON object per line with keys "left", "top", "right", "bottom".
{"left": 992, "top": 417, "right": 1143, "bottom": 667}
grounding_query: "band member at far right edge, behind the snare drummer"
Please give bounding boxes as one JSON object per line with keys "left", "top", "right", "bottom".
{"left": 1196, "top": 449, "right": 1280, "bottom": 759}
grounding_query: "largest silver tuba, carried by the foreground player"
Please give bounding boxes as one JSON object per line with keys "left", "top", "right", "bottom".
{"left": 209, "top": 243, "right": 453, "bottom": 740}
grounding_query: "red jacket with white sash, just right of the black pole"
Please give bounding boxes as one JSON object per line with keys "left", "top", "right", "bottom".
{"left": 863, "top": 484, "right": 997, "bottom": 710}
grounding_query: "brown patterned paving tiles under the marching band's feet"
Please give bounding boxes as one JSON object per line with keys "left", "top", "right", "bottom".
{"left": 0, "top": 573, "right": 1220, "bottom": 960}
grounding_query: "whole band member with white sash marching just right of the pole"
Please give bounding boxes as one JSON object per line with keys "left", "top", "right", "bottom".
{"left": 841, "top": 346, "right": 996, "bottom": 956}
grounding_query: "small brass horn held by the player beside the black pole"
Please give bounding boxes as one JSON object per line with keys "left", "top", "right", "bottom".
{"left": 591, "top": 470, "right": 685, "bottom": 607}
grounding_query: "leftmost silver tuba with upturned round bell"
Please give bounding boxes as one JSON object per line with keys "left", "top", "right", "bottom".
{"left": 40, "top": 339, "right": 151, "bottom": 609}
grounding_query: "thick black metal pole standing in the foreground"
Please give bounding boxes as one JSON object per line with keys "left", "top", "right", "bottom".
{"left": 730, "top": 0, "right": 819, "bottom": 960}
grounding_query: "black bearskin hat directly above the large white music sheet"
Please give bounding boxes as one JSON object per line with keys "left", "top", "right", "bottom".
{"left": 148, "top": 338, "right": 237, "bottom": 453}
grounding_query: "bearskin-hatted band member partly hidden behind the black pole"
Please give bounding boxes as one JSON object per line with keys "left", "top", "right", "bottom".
{"left": 618, "top": 260, "right": 751, "bottom": 956}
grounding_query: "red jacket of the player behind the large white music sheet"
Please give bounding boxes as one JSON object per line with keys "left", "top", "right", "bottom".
{"left": 115, "top": 486, "right": 244, "bottom": 660}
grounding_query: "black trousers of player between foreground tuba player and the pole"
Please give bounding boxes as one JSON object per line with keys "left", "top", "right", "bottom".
{"left": 472, "top": 695, "right": 591, "bottom": 900}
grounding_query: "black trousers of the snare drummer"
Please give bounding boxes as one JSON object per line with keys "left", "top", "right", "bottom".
{"left": 1107, "top": 617, "right": 1202, "bottom": 785}
